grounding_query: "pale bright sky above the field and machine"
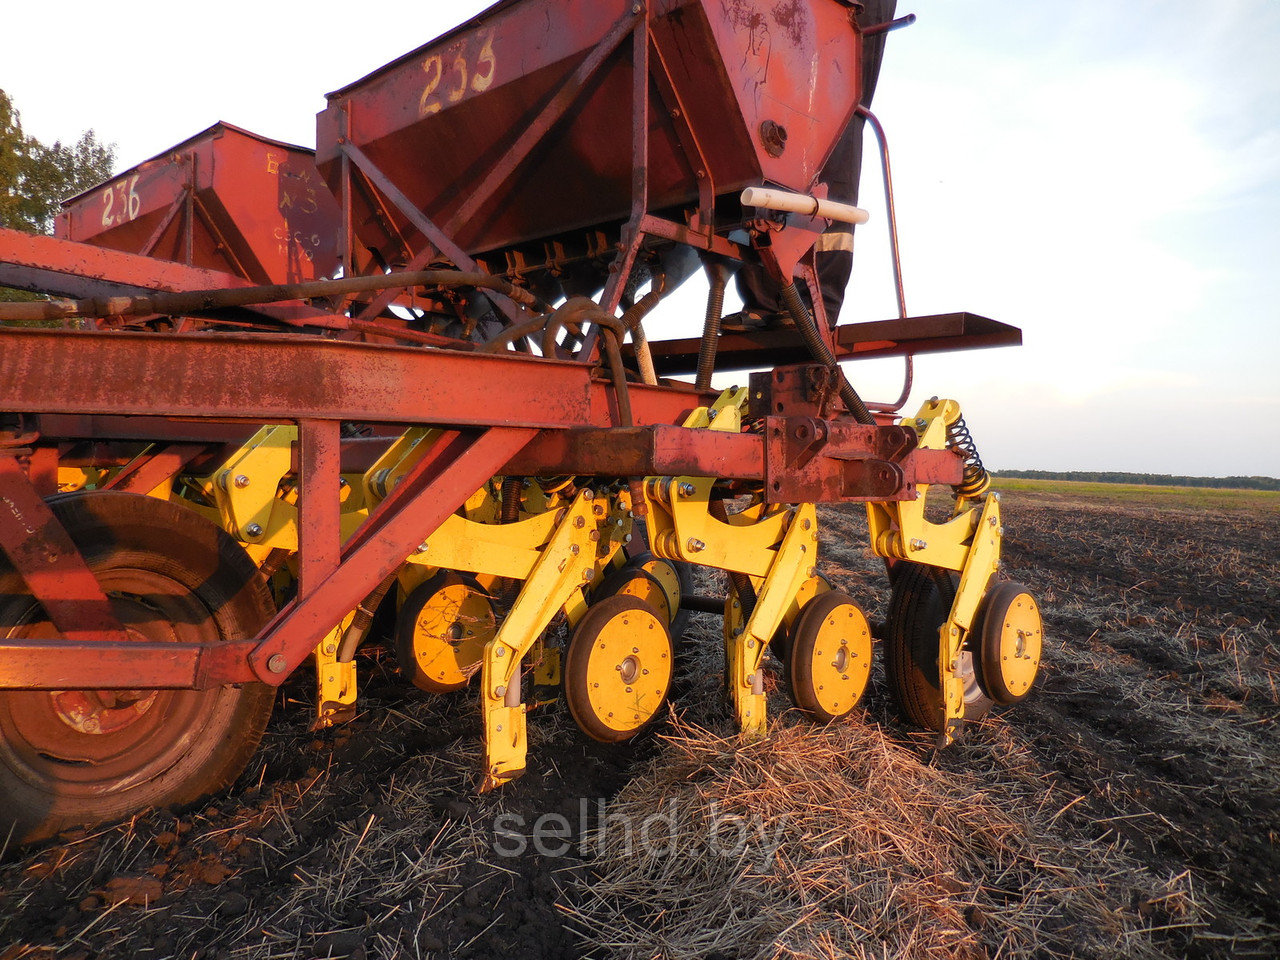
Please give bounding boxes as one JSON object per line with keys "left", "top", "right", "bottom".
{"left": 0, "top": 0, "right": 1280, "bottom": 476}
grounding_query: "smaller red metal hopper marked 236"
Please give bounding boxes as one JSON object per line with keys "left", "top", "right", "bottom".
{"left": 56, "top": 123, "right": 338, "bottom": 283}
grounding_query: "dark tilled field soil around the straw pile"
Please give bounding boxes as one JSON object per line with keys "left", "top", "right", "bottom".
{"left": 0, "top": 494, "right": 1280, "bottom": 960}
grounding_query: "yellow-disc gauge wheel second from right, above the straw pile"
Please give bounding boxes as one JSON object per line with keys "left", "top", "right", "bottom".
{"left": 787, "top": 590, "right": 872, "bottom": 723}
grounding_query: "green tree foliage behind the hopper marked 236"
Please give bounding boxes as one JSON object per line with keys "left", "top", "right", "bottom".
{"left": 0, "top": 90, "right": 115, "bottom": 233}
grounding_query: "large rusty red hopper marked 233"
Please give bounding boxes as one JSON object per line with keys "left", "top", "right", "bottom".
{"left": 317, "top": 0, "right": 861, "bottom": 262}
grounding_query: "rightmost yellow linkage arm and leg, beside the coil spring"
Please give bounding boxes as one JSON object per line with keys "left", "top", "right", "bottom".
{"left": 867, "top": 398, "right": 1004, "bottom": 746}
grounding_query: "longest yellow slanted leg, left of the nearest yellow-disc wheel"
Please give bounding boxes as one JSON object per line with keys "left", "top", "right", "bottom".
{"left": 480, "top": 490, "right": 617, "bottom": 790}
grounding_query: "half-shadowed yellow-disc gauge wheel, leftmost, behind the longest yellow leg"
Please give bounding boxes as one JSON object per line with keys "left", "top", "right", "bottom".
{"left": 396, "top": 570, "right": 498, "bottom": 694}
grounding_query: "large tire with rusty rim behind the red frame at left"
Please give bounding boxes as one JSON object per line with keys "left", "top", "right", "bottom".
{"left": 0, "top": 492, "right": 275, "bottom": 847}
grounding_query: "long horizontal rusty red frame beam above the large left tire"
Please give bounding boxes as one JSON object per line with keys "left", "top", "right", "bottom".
{"left": 0, "top": 329, "right": 705, "bottom": 429}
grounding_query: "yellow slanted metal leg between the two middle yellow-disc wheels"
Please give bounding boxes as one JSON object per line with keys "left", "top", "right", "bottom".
{"left": 724, "top": 503, "right": 818, "bottom": 736}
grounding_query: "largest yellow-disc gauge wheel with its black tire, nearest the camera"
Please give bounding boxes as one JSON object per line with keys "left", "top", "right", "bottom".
{"left": 564, "top": 594, "right": 673, "bottom": 744}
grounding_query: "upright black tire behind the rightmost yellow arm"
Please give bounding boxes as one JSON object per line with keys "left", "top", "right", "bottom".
{"left": 884, "top": 562, "right": 993, "bottom": 731}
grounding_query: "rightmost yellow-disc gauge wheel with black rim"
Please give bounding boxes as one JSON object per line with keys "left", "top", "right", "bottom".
{"left": 973, "top": 581, "right": 1044, "bottom": 704}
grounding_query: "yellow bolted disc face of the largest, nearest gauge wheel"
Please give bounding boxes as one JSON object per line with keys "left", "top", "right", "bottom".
{"left": 573, "top": 609, "right": 672, "bottom": 733}
